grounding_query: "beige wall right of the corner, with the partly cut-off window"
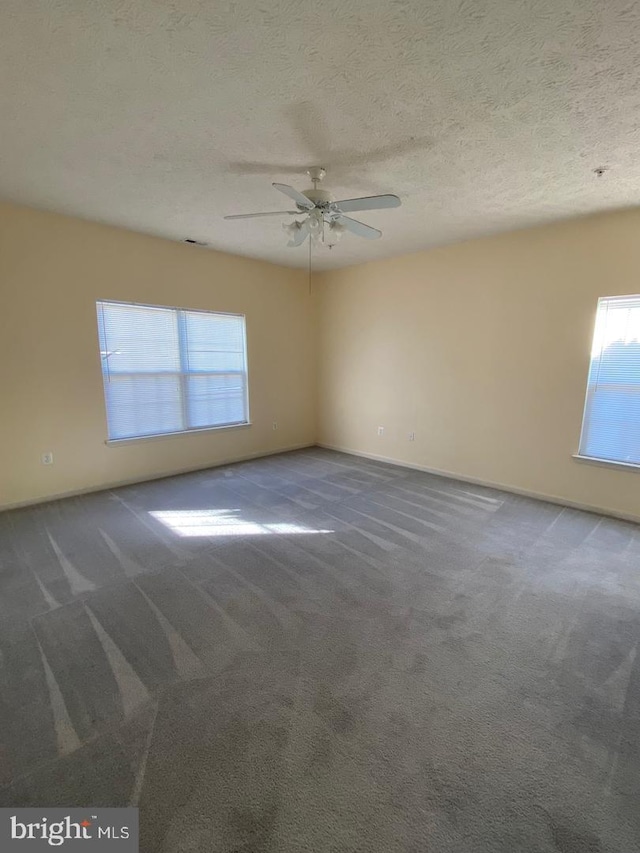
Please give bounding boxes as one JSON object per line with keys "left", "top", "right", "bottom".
{"left": 315, "top": 211, "right": 640, "bottom": 518}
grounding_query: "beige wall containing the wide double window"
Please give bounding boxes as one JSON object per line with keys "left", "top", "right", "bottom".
{"left": 0, "top": 205, "right": 316, "bottom": 506}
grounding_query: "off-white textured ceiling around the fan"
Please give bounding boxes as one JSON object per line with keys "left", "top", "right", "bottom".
{"left": 0, "top": 0, "right": 640, "bottom": 268}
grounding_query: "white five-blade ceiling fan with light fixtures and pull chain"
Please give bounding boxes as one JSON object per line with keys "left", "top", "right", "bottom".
{"left": 224, "top": 166, "right": 401, "bottom": 248}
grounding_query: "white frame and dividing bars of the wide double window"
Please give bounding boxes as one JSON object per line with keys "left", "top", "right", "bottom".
{"left": 96, "top": 299, "right": 252, "bottom": 445}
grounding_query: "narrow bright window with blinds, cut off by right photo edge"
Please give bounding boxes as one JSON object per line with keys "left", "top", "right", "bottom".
{"left": 580, "top": 295, "right": 640, "bottom": 465}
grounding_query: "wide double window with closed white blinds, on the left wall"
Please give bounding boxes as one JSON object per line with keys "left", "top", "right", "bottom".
{"left": 97, "top": 302, "right": 248, "bottom": 440}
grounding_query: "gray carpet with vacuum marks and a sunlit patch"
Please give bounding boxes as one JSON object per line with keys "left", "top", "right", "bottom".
{"left": 0, "top": 449, "right": 640, "bottom": 853}
